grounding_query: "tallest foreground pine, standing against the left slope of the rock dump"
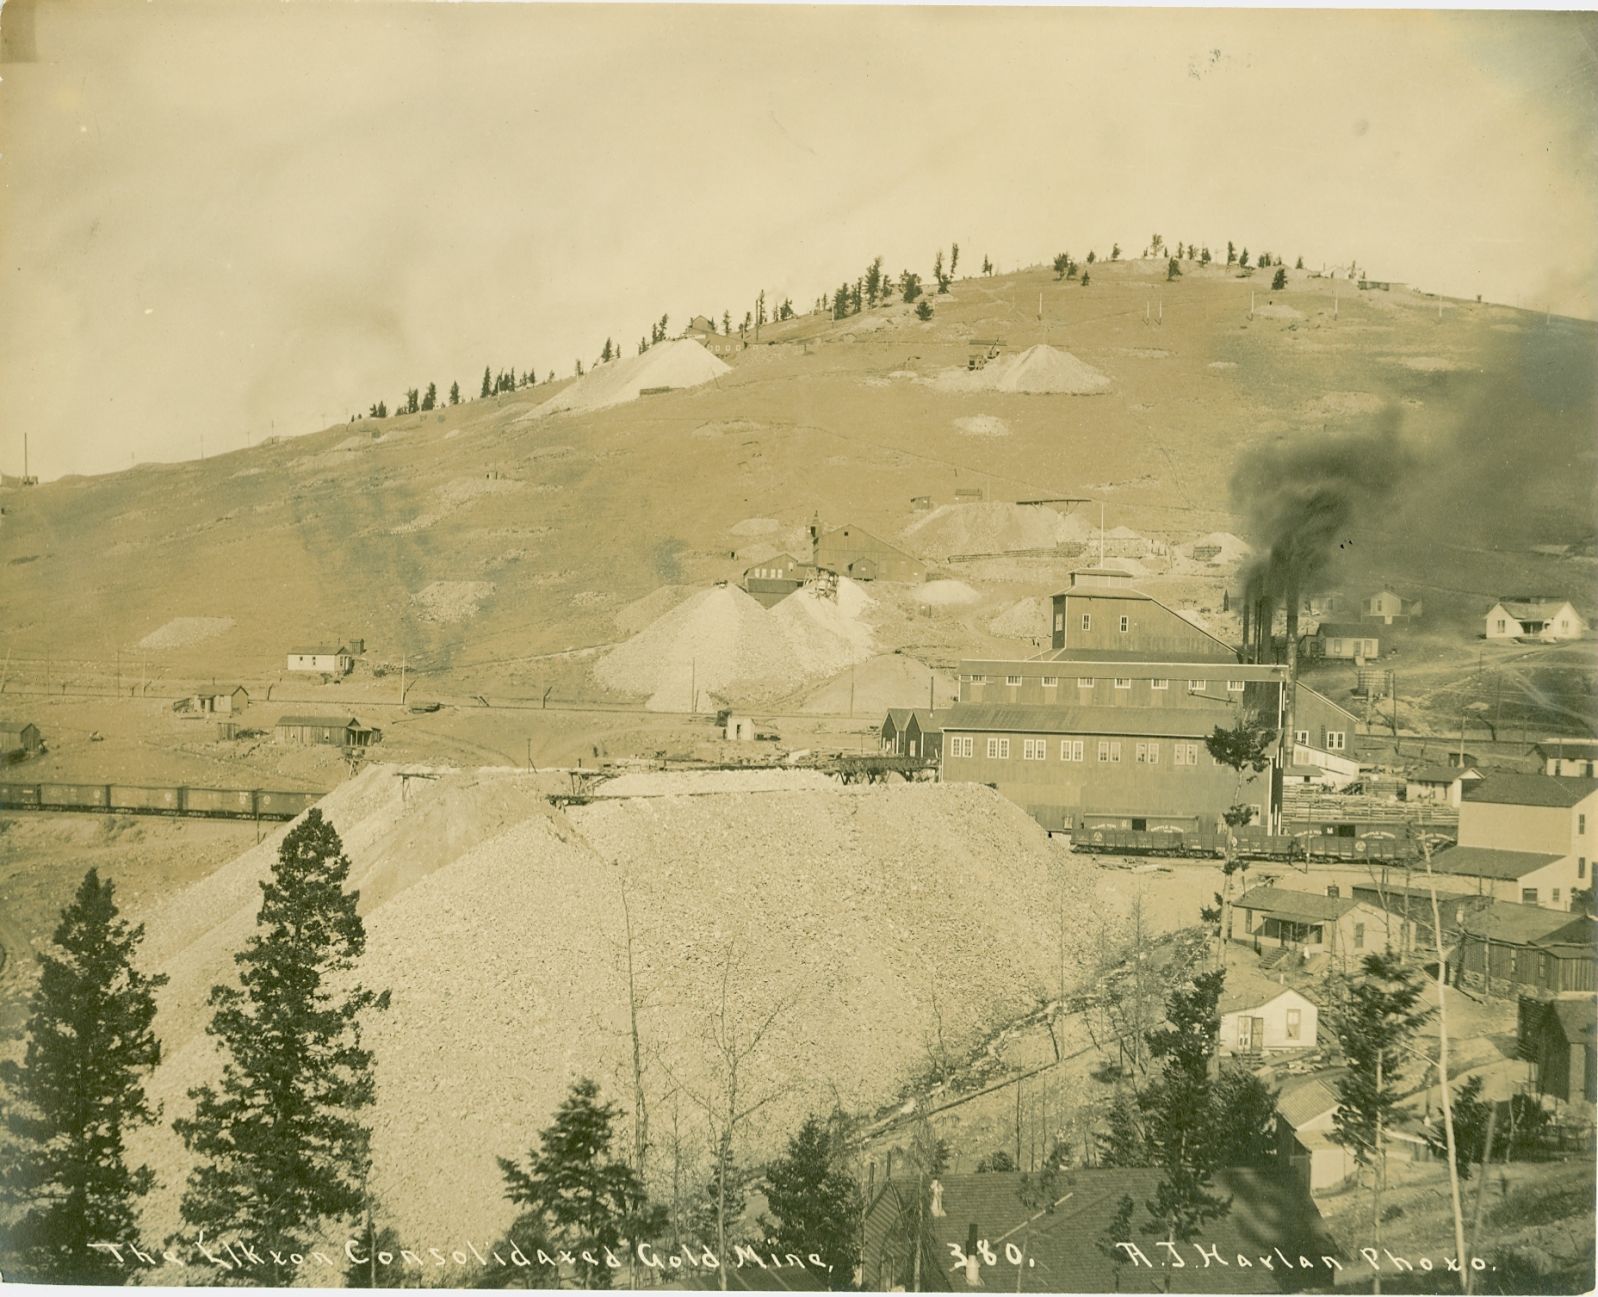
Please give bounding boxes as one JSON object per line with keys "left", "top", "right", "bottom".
{"left": 173, "top": 807, "right": 388, "bottom": 1284}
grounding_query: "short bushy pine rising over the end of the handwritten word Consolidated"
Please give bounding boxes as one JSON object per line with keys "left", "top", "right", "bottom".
{"left": 499, "top": 1078, "right": 660, "bottom": 1287}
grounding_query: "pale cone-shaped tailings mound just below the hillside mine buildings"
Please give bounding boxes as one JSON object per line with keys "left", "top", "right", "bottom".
{"left": 594, "top": 577, "right": 874, "bottom": 711}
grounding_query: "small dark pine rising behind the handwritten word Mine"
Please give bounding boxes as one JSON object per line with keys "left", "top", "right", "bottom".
{"left": 761, "top": 1117, "right": 861, "bottom": 1289}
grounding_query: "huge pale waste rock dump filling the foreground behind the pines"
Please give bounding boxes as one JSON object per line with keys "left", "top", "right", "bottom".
{"left": 121, "top": 765, "right": 1119, "bottom": 1246}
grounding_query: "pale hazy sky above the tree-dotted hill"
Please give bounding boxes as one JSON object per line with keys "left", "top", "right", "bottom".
{"left": 0, "top": 0, "right": 1598, "bottom": 479}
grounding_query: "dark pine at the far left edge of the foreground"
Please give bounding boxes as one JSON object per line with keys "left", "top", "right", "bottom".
{"left": 0, "top": 869, "right": 166, "bottom": 1284}
